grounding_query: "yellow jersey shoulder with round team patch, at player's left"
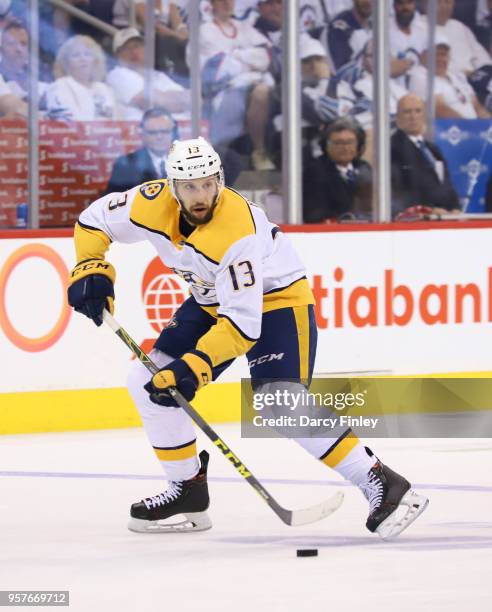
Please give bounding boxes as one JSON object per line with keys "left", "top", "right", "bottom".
{"left": 130, "top": 179, "right": 178, "bottom": 235}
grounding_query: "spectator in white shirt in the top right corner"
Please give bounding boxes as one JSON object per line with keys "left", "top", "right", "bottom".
{"left": 418, "top": 0, "right": 491, "bottom": 75}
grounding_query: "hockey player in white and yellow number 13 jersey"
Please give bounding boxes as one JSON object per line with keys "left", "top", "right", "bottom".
{"left": 68, "top": 138, "right": 428, "bottom": 537}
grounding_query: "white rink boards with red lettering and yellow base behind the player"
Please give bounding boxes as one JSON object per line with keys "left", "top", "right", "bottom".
{"left": 0, "top": 222, "right": 492, "bottom": 433}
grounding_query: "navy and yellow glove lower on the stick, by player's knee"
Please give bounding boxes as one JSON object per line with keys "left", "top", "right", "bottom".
{"left": 144, "top": 351, "right": 212, "bottom": 407}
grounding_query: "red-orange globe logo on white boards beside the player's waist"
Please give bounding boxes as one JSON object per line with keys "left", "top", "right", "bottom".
{"left": 142, "top": 257, "right": 188, "bottom": 333}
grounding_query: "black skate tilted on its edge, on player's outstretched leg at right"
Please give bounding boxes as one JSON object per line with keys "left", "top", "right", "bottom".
{"left": 359, "top": 447, "right": 429, "bottom": 540}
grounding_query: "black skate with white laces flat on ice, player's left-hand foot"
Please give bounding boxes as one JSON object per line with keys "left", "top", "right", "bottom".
{"left": 128, "top": 451, "right": 212, "bottom": 533}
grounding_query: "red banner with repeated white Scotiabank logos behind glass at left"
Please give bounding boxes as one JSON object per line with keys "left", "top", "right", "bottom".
{"left": 0, "top": 120, "right": 203, "bottom": 228}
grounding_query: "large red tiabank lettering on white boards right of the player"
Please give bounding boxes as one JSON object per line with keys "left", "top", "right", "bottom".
{"left": 312, "top": 268, "right": 492, "bottom": 329}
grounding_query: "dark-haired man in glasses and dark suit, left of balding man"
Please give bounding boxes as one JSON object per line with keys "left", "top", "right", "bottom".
{"left": 303, "top": 118, "right": 372, "bottom": 223}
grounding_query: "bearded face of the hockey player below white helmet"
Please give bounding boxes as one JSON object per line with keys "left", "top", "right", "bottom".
{"left": 176, "top": 176, "right": 219, "bottom": 225}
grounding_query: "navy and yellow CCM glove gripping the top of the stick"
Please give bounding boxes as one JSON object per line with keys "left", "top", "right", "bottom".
{"left": 68, "top": 259, "right": 116, "bottom": 327}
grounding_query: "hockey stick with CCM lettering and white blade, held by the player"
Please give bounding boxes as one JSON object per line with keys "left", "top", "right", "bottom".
{"left": 103, "top": 310, "right": 343, "bottom": 526}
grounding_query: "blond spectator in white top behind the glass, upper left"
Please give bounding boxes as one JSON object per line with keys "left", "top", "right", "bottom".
{"left": 46, "top": 35, "right": 117, "bottom": 121}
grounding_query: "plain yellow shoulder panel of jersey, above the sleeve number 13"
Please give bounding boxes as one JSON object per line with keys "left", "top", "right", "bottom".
{"left": 187, "top": 187, "right": 256, "bottom": 263}
